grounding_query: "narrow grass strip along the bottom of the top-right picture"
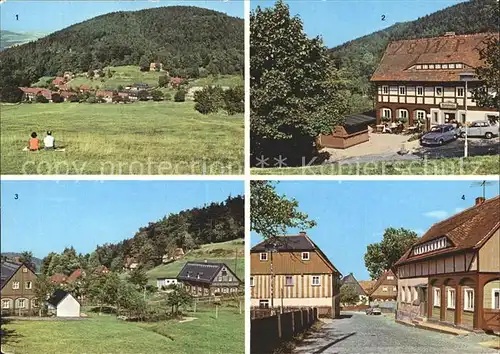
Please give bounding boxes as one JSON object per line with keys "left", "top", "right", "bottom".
{"left": 252, "top": 155, "right": 500, "bottom": 176}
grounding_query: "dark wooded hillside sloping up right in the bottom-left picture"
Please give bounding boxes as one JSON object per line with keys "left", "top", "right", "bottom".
{"left": 89, "top": 196, "right": 245, "bottom": 270}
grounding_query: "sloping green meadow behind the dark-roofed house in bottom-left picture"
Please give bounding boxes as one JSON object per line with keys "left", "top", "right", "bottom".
{"left": 147, "top": 239, "right": 245, "bottom": 285}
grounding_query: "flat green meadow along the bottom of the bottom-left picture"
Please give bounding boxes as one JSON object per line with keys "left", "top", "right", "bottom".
{"left": 2, "top": 304, "right": 245, "bottom": 354}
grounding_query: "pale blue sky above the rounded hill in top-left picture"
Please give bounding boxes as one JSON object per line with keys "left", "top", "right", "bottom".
{"left": 0, "top": 0, "right": 244, "bottom": 33}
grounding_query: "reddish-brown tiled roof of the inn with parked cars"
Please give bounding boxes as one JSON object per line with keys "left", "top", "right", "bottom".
{"left": 371, "top": 33, "right": 498, "bottom": 82}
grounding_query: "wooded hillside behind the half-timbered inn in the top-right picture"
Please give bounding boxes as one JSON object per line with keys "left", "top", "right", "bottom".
{"left": 331, "top": 0, "right": 499, "bottom": 95}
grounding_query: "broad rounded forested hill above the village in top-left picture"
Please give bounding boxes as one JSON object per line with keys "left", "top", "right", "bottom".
{"left": 0, "top": 6, "right": 244, "bottom": 83}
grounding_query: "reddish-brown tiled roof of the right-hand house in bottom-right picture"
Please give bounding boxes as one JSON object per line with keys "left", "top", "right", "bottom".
{"left": 395, "top": 196, "right": 500, "bottom": 265}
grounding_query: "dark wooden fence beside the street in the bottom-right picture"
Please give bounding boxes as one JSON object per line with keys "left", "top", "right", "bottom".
{"left": 250, "top": 308, "right": 318, "bottom": 354}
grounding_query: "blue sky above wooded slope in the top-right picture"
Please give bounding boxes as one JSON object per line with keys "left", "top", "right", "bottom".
{"left": 251, "top": 0, "right": 463, "bottom": 47}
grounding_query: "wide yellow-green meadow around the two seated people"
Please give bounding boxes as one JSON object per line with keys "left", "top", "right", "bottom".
{"left": 0, "top": 101, "right": 244, "bottom": 175}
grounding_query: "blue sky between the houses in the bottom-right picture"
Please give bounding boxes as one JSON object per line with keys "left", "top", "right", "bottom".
{"left": 251, "top": 181, "right": 499, "bottom": 280}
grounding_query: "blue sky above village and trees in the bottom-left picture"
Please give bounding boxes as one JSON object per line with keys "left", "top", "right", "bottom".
{"left": 1, "top": 181, "right": 244, "bottom": 258}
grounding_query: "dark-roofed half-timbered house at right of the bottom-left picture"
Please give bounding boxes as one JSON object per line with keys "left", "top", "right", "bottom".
{"left": 177, "top": 261, "right": 241, "bottom": 297}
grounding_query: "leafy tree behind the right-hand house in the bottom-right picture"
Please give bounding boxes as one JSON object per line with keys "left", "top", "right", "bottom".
{"left": 364, "top": 227, "right": 419, "bottom": 279}
